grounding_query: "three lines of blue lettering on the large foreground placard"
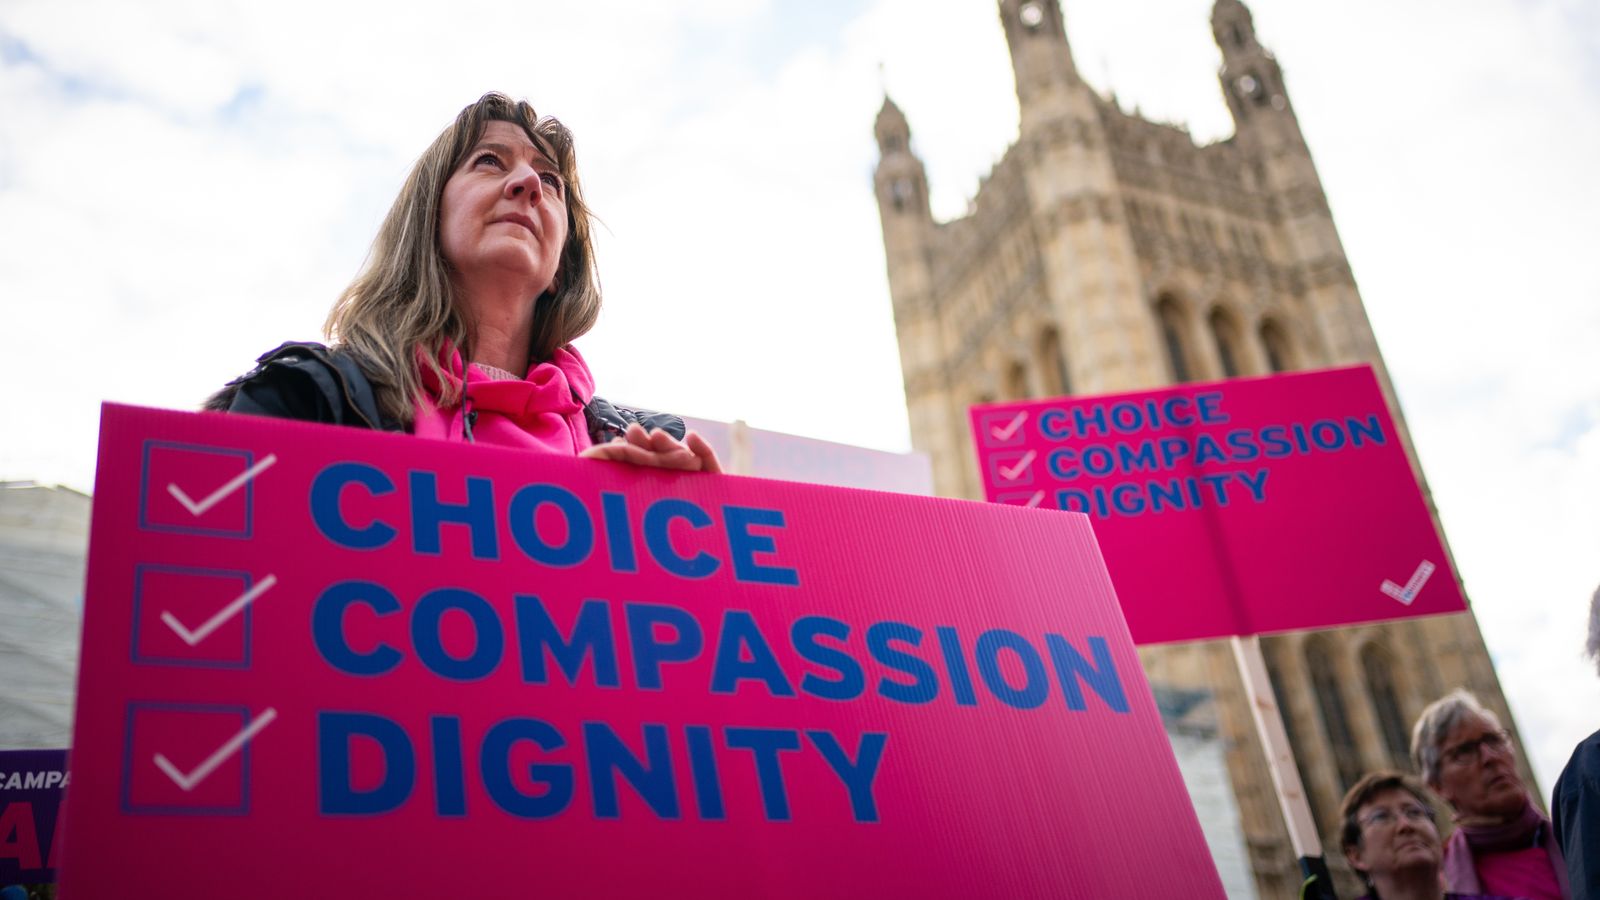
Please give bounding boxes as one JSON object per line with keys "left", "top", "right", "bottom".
{"left": 310, "top": 463, "right": 1130, "bottom": 822}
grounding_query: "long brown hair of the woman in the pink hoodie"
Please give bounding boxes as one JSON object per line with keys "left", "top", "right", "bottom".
{"left": 323, "top": 93, "right": 600, "bottom": 426}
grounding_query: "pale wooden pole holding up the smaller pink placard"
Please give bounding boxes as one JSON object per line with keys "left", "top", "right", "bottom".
{"left": 1232, "top": 634, "right": 1338, "bottom": 900}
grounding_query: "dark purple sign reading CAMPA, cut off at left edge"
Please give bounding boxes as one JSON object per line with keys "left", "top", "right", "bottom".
{"left": 0, "top": 749, "right": 67, "bottom": 886}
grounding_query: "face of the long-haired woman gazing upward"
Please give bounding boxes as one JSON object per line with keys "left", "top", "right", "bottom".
{"left": 438, "top": 122, "right": 566, "bottom": 298}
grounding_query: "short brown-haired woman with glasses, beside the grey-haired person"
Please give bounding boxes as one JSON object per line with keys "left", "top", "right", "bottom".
{"left": 1339, "top": 772, "right": 1506, "bottom": 900}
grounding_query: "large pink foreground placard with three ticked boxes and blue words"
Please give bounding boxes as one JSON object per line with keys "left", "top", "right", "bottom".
{"left": 59, "top": 405, "right": 1222, "bottom": 900}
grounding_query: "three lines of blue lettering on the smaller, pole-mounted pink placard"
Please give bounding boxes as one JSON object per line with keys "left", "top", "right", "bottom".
{"left": 1037, "top": 391, "right": 1387, "bottom": 519}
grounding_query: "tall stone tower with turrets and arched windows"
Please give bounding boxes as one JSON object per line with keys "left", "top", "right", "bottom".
{"left": 875, "top": 0, "right": 1533, "bottom": 897}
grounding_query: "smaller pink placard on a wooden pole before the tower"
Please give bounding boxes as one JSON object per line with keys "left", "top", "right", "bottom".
{"left": 971, "top": 365, "right": 1466, "bottom": 644}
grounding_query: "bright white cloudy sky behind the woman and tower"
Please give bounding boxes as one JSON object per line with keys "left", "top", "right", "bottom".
{"left": 0, "top": 0, "right": 1600, "bottom": 791}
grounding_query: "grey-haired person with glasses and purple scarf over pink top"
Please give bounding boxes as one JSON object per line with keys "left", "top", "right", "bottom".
{"left": 1411, "top": 690, "right": 1571, "bottom": 900}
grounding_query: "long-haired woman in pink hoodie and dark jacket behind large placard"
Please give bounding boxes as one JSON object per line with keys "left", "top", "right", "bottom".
{"left": 206, "top": 93, "right": 720, "bottom": 472}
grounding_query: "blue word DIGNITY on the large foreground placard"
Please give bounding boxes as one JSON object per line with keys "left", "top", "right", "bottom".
{"left": 317, "top": 713, "right": 888, "bottom": 822}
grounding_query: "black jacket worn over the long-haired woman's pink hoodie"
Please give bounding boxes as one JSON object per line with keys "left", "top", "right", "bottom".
{"left": 205, "top": 341, "right": 685, "bottom": 444}
